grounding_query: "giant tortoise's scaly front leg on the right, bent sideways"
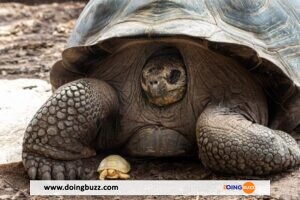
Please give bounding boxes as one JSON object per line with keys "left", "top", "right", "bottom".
{"left": 196, "top": 106, "right": 300, "bottom": 175}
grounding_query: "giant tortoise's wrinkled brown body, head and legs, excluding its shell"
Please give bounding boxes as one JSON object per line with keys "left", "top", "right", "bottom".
{"left": 23, "top": 42, "right": 300, "bottom": 179}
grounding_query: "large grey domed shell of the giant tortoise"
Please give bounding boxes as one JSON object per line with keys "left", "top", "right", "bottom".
{"left": 51, "top": 0, "right": 300, "bottom": 102}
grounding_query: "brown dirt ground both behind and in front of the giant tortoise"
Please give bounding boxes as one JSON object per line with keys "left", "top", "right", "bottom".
{"left": 0, "top": 0, "right": 300, "bottom": 200}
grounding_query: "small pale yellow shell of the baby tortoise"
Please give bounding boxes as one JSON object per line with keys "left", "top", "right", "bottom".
{"left": 97, "top": 155, "right": 130, "bottom": 173}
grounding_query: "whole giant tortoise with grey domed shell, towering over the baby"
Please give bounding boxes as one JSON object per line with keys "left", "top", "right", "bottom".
{"left": 22, "top": 0, "right": 300, "bottom": 179}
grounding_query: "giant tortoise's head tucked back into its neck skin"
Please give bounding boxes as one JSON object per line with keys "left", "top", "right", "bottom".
{"left": 141, "top": 48, "right": 187, "bottom": 106}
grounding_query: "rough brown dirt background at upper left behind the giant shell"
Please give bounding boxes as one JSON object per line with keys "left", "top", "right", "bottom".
{"left": 0, "top": 0, "right": 86, "bottom": 79}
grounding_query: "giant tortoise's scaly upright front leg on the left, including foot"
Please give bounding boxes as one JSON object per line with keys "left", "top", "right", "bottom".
{"left": 22, "top": 79, "right": 118, "bottom": 179}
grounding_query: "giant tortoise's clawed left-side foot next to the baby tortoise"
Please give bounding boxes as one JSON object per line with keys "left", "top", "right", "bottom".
{"left": 23, "top": 153, "right": 95, "bottom": 180}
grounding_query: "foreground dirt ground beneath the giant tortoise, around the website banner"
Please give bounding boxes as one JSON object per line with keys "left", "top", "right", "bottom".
{"left": 0, "top": 155, "right": 300, "bottom": 200}
